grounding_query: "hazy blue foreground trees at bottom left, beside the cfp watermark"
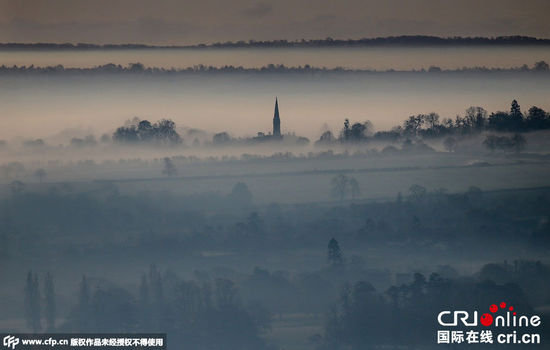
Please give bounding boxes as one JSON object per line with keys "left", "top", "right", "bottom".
{"left": 60, "top": 265, "right": 270, "bottom": 350}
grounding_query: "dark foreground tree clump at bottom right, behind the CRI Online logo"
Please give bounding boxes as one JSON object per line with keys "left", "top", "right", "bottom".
{"left": 322, "top": 268, "right": 548, "bottom": 350}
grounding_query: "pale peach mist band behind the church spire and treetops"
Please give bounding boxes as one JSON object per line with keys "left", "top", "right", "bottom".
{"left": 0, "top": 67, "right": 550, "bottom": 144}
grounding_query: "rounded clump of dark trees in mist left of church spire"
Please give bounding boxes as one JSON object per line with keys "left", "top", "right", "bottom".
{"left": 113, "top": 118, "right": 182, "bottom": 146}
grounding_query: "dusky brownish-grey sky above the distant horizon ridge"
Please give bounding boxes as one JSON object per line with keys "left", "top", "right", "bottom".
{"left": 0, "top": 0, "right": 550, "bottom": 44}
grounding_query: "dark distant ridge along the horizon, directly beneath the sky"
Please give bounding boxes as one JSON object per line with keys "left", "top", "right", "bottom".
{"left": 0, "top": 35, "right": 550, "bottom": 50}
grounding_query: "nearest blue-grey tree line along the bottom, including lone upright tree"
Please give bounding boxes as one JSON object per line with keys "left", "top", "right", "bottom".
{"left": 30, "top": 262, "right": 550, "bottom": 350}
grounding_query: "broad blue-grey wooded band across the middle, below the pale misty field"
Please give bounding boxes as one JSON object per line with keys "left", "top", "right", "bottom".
{"left": 4, "top": 184, "right": 550, "bottom": 258}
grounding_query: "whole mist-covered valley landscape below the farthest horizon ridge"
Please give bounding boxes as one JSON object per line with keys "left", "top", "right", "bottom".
{"left": 0, "top": 42, "right": 550, "bottom": 350}
